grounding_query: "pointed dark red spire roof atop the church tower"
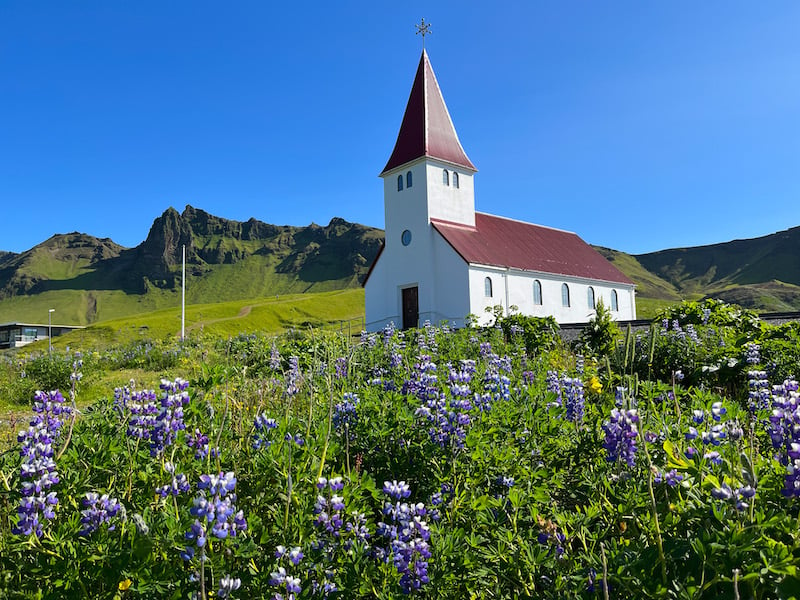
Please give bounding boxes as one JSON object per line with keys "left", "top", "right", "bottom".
{"left": 381, "top": 50, "right": 477, "bottom": 175}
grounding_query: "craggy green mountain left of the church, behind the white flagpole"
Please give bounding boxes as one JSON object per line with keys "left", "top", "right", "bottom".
{"left": 0, "top": 206, "right": 383, "bottom": 324}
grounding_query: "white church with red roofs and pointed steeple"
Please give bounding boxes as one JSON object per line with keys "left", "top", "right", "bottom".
{"left": 364, "top": 50, "right": 636, "bottom": 331}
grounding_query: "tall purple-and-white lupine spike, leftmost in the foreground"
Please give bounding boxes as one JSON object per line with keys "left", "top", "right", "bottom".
{"left": 11, "top": 390, "right": 72, "bottom": 537}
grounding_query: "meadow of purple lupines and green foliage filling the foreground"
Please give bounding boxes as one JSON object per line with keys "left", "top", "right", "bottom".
{"left": 0, "top": 301, "right": 800, "bottom": 600}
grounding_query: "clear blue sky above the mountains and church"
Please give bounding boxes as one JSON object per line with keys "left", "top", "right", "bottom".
{"left": 0, "top": 0, "right": 800, "bottom": 253}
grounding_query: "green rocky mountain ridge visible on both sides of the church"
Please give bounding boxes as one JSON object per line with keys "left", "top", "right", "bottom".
{"left": 0, "top": 205, "right": 800, "bottom": 325}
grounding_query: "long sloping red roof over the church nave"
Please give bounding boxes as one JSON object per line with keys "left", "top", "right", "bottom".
{"left": 431, "top": 212, "right": 633, "bottom": 285}
